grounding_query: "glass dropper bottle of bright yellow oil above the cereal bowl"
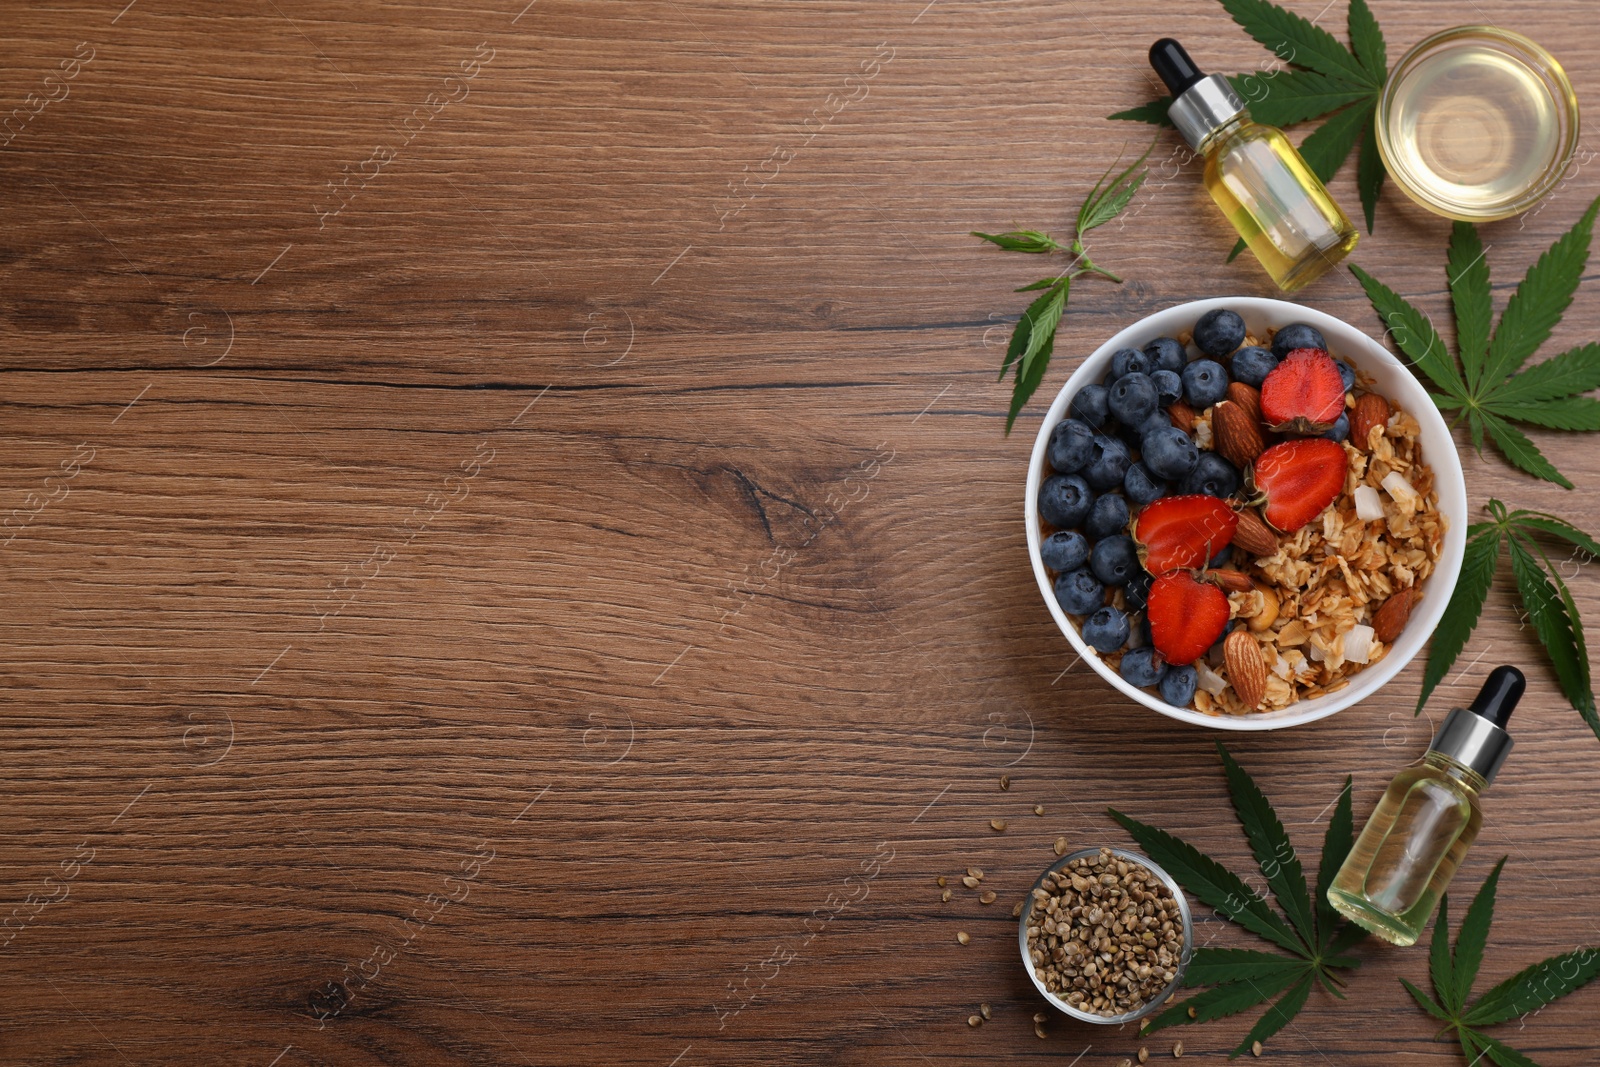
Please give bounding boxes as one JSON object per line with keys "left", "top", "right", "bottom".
{"left": 1150, "top": 37, "right": 1358, "bottom": 293}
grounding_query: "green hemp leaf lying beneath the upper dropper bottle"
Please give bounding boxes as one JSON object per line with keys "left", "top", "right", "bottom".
{"left": 1110, "top": 0, "right": 1389, "bottom": 235}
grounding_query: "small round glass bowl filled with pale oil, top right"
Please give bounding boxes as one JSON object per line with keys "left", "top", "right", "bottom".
{"left": 1376, "top": 26, "right": 1578, "bottom": 222}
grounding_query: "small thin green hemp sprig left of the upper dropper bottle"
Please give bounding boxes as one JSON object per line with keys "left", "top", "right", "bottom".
{"left": 973, "top": 144, "right": 1155, "bottom": 434}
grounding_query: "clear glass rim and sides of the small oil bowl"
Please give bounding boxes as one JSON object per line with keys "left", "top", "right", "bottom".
{"left": 1376, "top": 26, "right": 1578, "bottom": 222}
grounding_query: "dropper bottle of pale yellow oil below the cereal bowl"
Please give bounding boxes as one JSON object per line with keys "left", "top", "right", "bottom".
{"left": 1328, "top": 667, "right": 1526, "bottom": 945}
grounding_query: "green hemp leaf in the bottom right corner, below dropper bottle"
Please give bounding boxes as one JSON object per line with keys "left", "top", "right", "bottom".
{"left": 1400, "top": 859, "right": 1600, "bottom": 1067}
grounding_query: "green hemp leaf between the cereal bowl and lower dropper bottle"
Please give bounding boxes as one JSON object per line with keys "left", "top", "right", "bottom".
{"left": 1416, "top": 502, "right": 1600, "bottom": 737}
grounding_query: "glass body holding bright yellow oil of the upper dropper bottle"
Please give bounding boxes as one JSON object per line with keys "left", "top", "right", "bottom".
{"left": 1202, "top": 120, "right": 1358, "bottom": 293}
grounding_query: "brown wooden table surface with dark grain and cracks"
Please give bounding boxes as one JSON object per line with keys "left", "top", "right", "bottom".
{"left": 0, "top": 0, "right": 1600, "bottom": 1067}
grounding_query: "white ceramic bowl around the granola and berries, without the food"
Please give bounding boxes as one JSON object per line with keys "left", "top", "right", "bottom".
{"left": 1026, "top": 296, "right": 1467, "bottom": 729}
